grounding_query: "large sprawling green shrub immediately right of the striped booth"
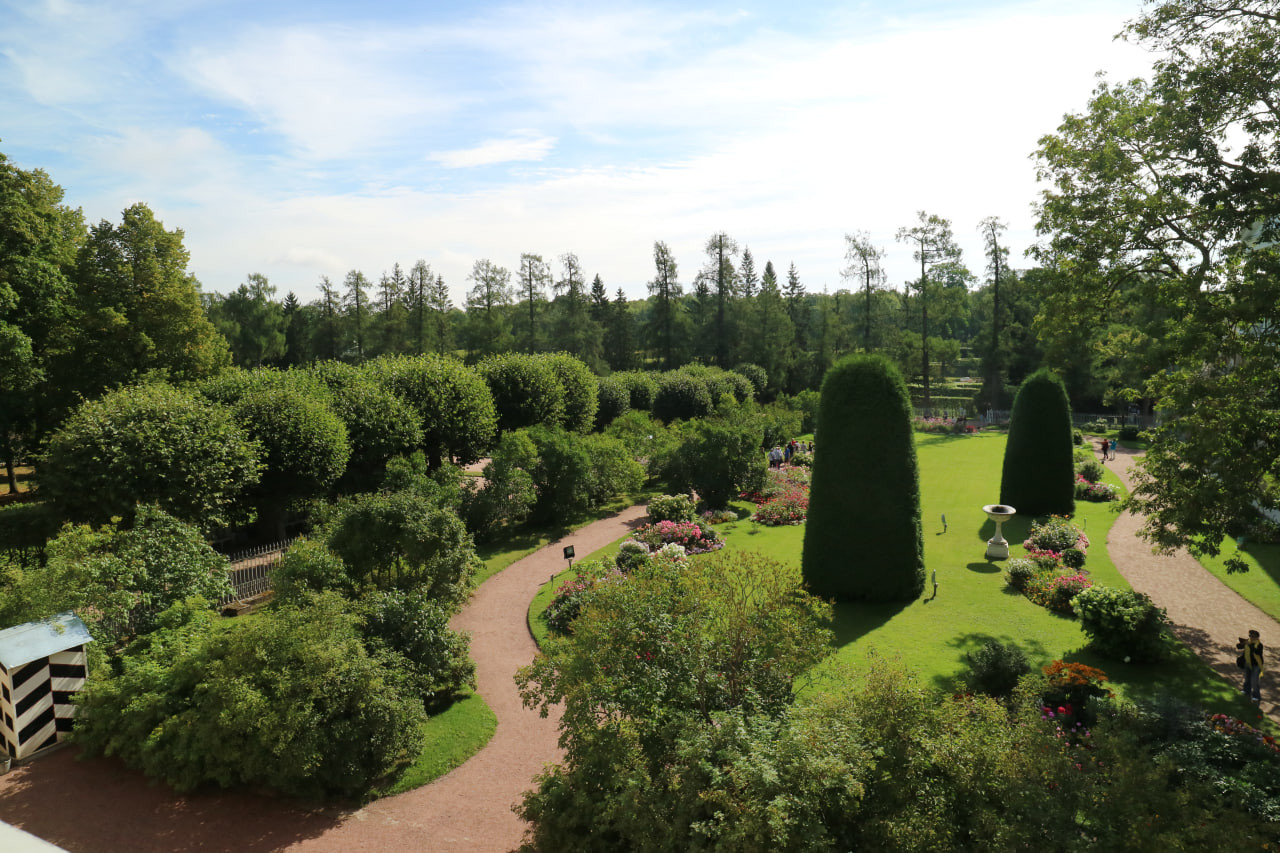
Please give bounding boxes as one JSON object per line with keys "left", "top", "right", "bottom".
{"left": 73, "top": 594, "right": 425, "bottom": 797}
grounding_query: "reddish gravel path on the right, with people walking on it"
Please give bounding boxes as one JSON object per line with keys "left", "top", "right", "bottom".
{"left": 1094, "top": 442, "right": 1280, "bottom": 722}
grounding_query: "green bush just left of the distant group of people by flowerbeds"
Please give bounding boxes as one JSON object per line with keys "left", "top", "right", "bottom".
{"left": 666, "top": 420, "right": 767, "bottom": 508}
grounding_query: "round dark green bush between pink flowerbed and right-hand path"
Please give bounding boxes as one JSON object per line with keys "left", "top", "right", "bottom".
{"left": 1074, "top": 587, "right": 1169, "bottom": 663}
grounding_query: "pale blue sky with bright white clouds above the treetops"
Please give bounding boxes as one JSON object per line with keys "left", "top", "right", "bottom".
{"left": 0, "top": 0, "right": 1152, "bottom": 306}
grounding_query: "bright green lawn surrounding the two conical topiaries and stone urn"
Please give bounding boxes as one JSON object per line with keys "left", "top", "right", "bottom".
{"left": 530, "top": 432, "right": 1266, "bottom": 725}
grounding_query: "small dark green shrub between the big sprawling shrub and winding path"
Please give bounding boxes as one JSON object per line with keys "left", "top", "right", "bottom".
{"left": 360, "top": 588, "right": 476, "bottom": 704}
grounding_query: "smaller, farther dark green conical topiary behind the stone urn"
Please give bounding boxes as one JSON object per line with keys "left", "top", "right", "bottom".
{"left": 1000, "top": 369, "right": 1075, "bottom": 516}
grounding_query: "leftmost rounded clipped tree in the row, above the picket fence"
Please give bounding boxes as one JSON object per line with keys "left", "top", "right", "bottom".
{"left": 38, "top": 384, "right": 261, "bottom": 533}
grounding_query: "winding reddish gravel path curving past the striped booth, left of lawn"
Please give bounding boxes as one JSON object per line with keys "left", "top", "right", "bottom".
{"left": 0, "top": 507, "right": 644, "bottom": 853}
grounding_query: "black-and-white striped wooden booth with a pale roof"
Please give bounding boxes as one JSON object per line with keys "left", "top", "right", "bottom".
{"left": 0, "top": 611, "right": 93, "bottom": 761}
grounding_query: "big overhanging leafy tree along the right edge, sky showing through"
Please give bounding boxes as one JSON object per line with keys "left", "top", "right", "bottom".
{"left": 1036, "top": 0, "right": 1280, "bottom": 555}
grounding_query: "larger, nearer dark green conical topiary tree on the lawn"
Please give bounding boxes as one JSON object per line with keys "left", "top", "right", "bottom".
{"left": 801, "top": 355, "right": 924, "bottom": 601}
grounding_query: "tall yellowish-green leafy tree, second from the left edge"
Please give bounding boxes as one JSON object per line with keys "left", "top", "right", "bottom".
{"left": 56, "top": 204, "right": 230, "bottom": 397}
